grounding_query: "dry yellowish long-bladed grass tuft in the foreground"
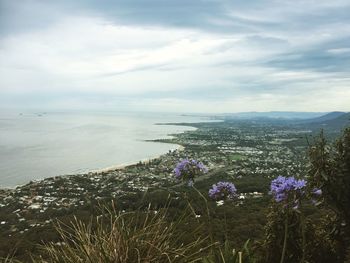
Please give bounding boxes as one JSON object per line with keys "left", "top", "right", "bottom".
{"left": 33, "top": 202, "right": 211, "bottom": 263}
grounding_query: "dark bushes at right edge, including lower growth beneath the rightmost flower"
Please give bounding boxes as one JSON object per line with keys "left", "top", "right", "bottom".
{"left": 261, "top": 128, "right": 350, "bottom": 263}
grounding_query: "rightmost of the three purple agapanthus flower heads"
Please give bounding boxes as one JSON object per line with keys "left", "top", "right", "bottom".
{"left": 271, "top": 176, "right": 306, "bottom": 208}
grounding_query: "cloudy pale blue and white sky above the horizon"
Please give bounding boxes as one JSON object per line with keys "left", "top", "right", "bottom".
{"left": 0, "top": 0, "right": 350, "bottom": 113}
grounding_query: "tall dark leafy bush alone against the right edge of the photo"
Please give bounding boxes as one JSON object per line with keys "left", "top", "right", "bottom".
{"left": 309, "top": 128, "right": 350, "bottom": 262}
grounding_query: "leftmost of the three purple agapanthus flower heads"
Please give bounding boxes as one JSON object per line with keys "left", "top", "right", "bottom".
{"left": 174, "top": 159, "right": 208, "bottom": 185}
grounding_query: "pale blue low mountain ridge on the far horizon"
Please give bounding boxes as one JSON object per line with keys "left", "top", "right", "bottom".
{"left": 221, "top": 111, "right": 325, "bottom": 120}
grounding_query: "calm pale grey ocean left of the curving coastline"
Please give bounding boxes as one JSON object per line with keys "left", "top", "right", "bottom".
{"left": 0, "top": 113, "right": 205, "bottom": 188}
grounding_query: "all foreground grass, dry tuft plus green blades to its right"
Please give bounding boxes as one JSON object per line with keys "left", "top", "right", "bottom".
{"left": 0, "top": 196, "right": 252, "bottom": 263}
